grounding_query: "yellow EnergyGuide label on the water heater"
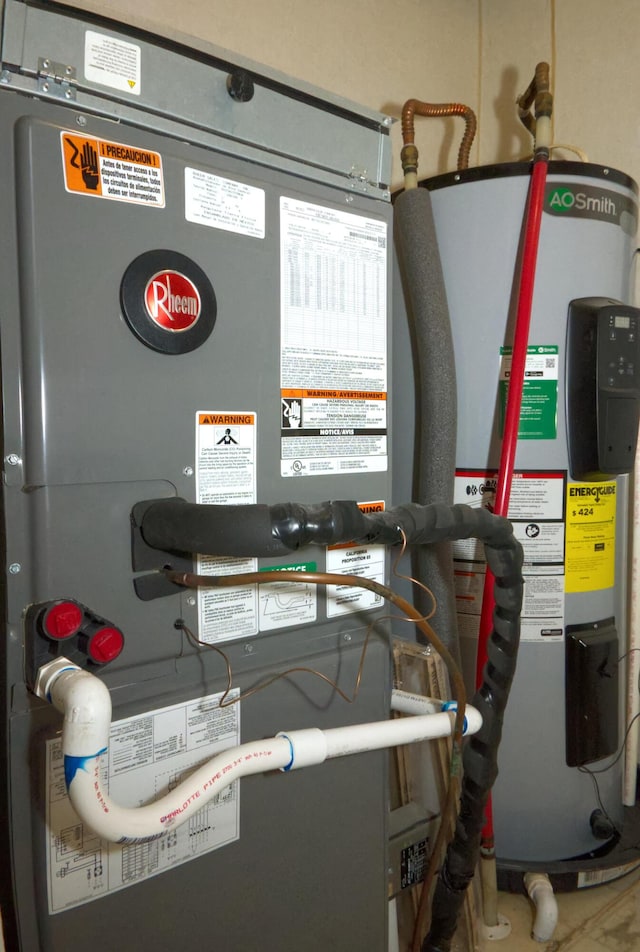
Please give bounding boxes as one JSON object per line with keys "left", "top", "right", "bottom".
{"left": 567, "top": 482, "right": 616, "bottom": 592}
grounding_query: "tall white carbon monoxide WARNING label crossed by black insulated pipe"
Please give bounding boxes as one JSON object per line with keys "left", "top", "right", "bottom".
{"left": 196, "top": 412, "right": 258, "bottom": 642}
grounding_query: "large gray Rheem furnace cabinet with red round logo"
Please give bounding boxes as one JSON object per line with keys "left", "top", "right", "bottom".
{"left": 0, "top": 0, "right": 400, "bottom": 952}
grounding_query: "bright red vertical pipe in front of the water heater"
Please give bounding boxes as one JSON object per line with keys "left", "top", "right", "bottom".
{"left": 476, "top": 153, "right": 548, "bottom": 850}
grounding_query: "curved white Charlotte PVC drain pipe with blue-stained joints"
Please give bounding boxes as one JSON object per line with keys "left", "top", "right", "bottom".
{"left": 36, "top": 659, "right": 482, "bottom": 843}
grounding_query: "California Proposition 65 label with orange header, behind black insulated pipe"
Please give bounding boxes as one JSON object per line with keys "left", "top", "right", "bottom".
{"left": 327, "top": 501, "right": 386, "bottom": 618}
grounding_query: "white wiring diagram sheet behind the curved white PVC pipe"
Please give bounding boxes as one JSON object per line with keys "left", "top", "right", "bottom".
{"left": 45, "top": 690, "right": 240, "bottom": 914}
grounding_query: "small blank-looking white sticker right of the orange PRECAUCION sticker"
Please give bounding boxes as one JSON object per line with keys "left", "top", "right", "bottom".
{"left": 184, "top": 168, "right": 265, "bottom": 238}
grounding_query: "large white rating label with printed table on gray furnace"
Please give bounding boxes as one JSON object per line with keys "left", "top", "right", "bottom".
{"left": 280, "top": 197, "right": 388, "bottom": 477}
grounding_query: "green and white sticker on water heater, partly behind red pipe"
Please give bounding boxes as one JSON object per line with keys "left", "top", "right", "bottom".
{"left": 498, "top": 344, "right": 559, "bottom": 440}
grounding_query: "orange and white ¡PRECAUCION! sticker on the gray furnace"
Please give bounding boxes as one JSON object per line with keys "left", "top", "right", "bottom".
{"left": 60, "top": 132, "right": 164, "bottom": 208}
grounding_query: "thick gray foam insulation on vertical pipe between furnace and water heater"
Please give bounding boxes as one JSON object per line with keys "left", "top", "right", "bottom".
{"left": 394, "top": 188, "right": 460, "bottom": 663}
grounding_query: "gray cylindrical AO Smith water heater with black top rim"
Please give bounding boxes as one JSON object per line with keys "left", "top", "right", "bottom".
{"left": 394, "top": 162, "right": 640, "bottom": 888}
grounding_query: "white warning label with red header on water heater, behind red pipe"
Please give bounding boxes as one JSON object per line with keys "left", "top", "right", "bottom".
{"left": 453, "top": 470, "right": 566, "bottom": 643}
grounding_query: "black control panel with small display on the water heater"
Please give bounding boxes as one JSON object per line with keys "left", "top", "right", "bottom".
{"left": 566, "top": 298, "right": 640, "bottom": 480}
